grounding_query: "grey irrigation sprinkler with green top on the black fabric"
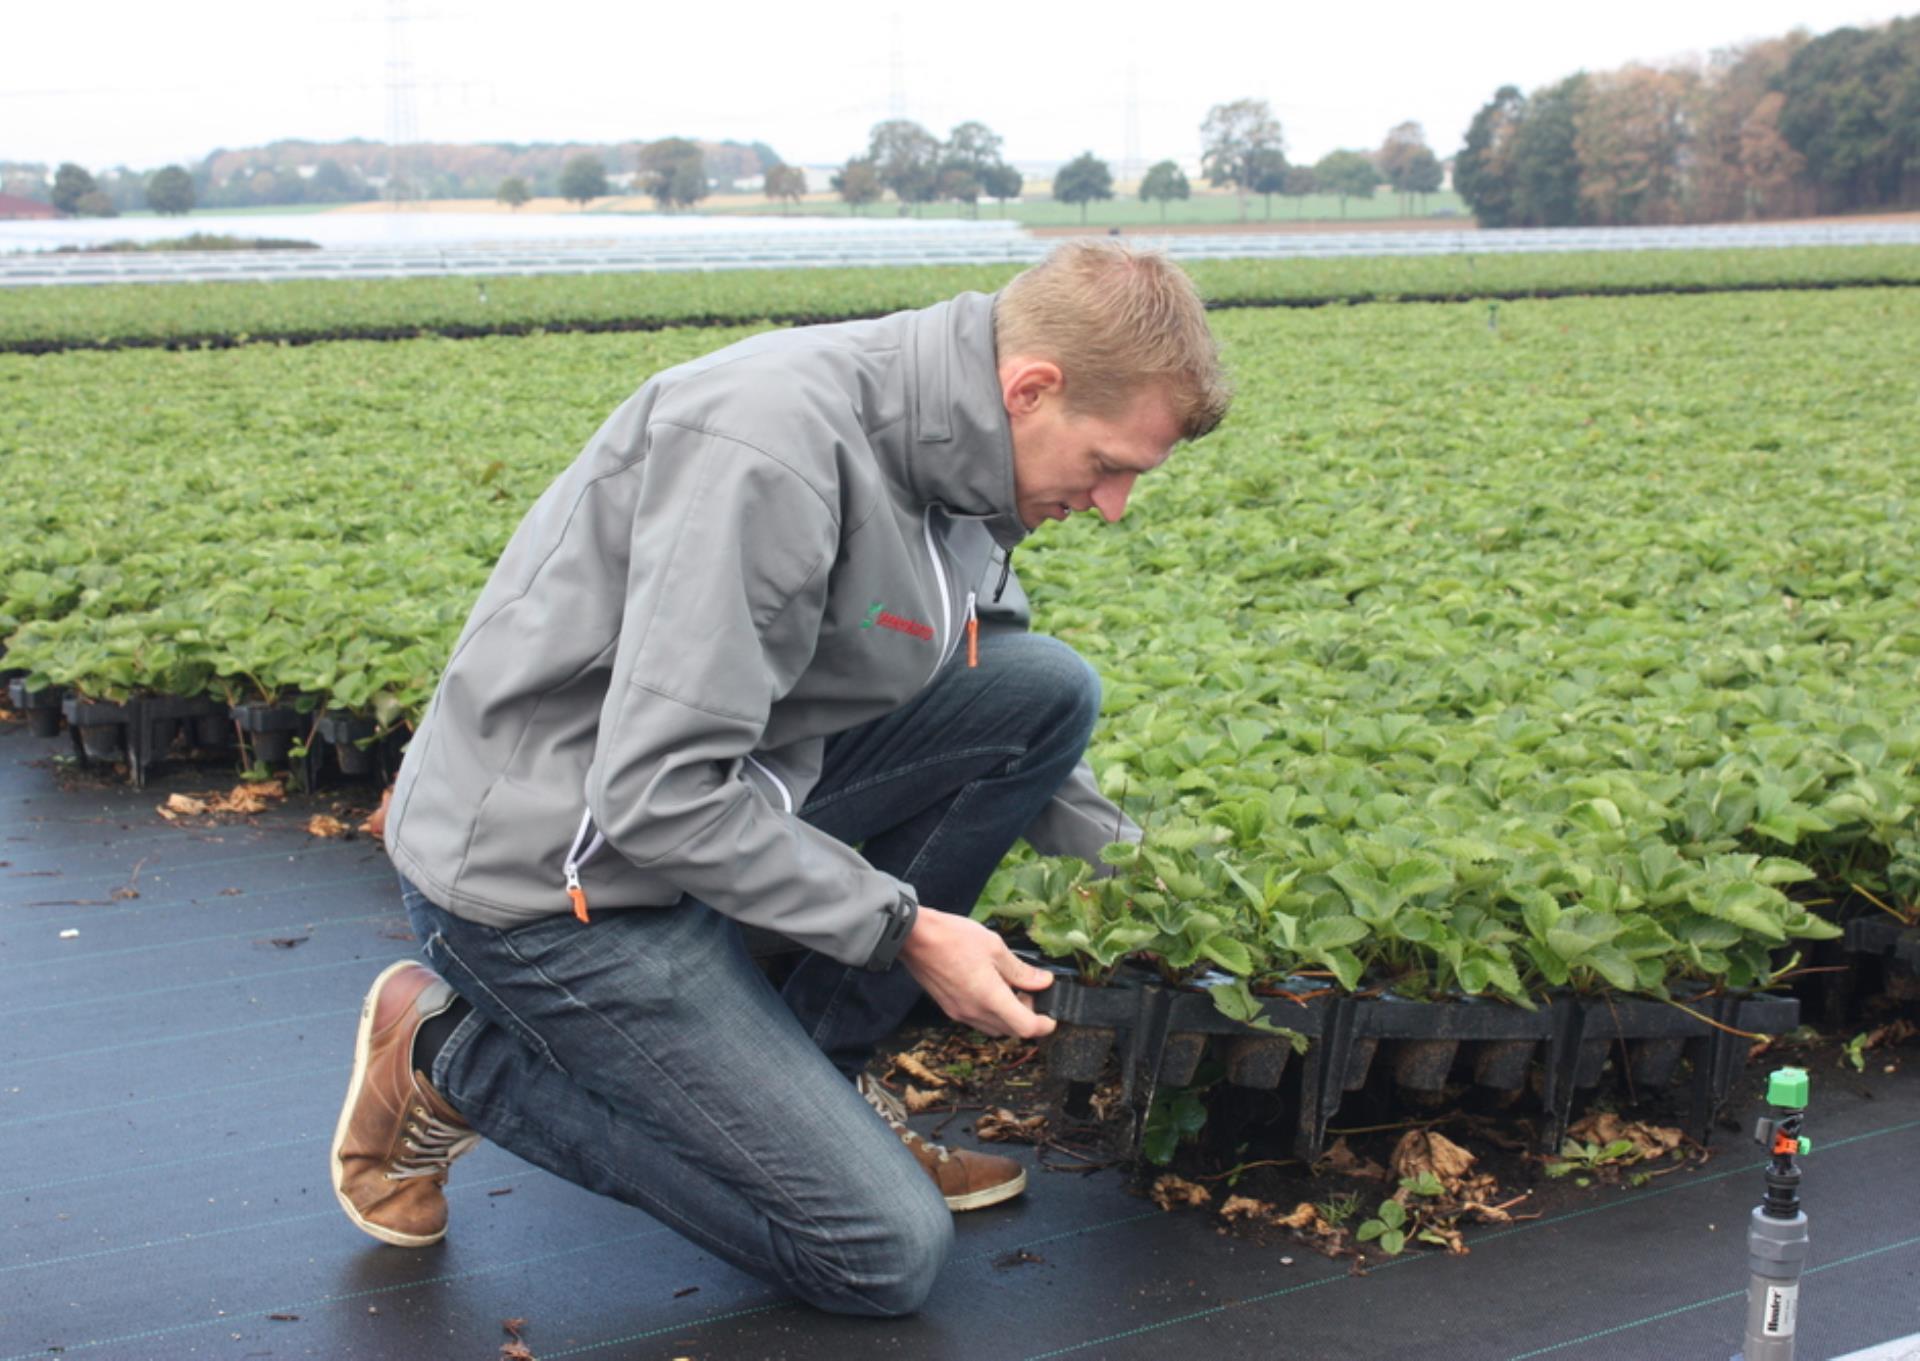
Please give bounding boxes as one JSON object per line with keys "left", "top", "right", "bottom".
{"left": 1734, "top": 1067, "right": 1812, "bottom": 1361}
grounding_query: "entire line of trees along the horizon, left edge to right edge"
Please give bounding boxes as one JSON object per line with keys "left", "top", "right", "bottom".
{"left": 22, "top": 17, "right": 1920, "bottom": 227}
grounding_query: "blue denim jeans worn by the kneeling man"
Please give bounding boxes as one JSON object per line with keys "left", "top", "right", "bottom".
{"left": 401, "top": 633, "right": 1098, "bottom": 1315}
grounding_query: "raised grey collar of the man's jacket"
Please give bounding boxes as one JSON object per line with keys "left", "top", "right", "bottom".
{"left": 906, "top": 294, "right": 1027, "bottom": 549}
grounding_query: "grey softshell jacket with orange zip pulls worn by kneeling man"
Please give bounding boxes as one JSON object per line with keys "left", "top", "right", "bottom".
{"left": 386, "top": 294, "right": 1139, "bottom": 967}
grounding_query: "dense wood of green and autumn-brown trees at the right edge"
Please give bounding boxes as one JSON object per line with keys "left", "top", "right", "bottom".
{"left": 1453, "top": 17, "right": 1920, "bottom": 227}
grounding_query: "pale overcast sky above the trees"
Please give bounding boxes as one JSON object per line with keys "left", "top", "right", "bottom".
{"left": 0, "top": 0, "right": 1914, "bottom": 169}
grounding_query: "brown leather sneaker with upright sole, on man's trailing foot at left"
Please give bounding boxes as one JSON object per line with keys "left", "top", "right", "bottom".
{"left": 332, "top": 960, "right": 480, "bottom": 1248}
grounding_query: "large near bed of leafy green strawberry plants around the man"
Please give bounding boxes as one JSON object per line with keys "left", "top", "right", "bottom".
{"left": 0, "top": 270, "right": 1920, "bottom": 1000}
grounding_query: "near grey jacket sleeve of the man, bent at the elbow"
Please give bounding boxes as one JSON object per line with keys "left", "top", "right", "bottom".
{"left": 588, "top": 422, "right": 916, "bottom": 967}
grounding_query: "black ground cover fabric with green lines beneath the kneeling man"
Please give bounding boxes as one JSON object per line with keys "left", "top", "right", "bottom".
{"left": 0, "top": 726, "right": 1920, "bottom": 1361}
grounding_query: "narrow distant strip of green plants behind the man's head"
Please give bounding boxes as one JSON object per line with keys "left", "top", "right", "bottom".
{"left": 0, "top": 246, "right": 1920, "bottom": 349}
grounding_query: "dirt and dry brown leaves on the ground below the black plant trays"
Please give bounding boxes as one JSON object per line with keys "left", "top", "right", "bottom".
{"left": 870, "top": 1008, "right": 1920, "bottom": 1271}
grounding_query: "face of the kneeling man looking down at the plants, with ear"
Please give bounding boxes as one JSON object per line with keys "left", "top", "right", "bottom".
{"left": 1000, "top": 359, "right": 1181, "bottom": 530}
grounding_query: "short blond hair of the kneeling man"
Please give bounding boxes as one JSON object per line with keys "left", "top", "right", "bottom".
{"left": 993, "top": 240, "right": 1233, "bottom": 440}
